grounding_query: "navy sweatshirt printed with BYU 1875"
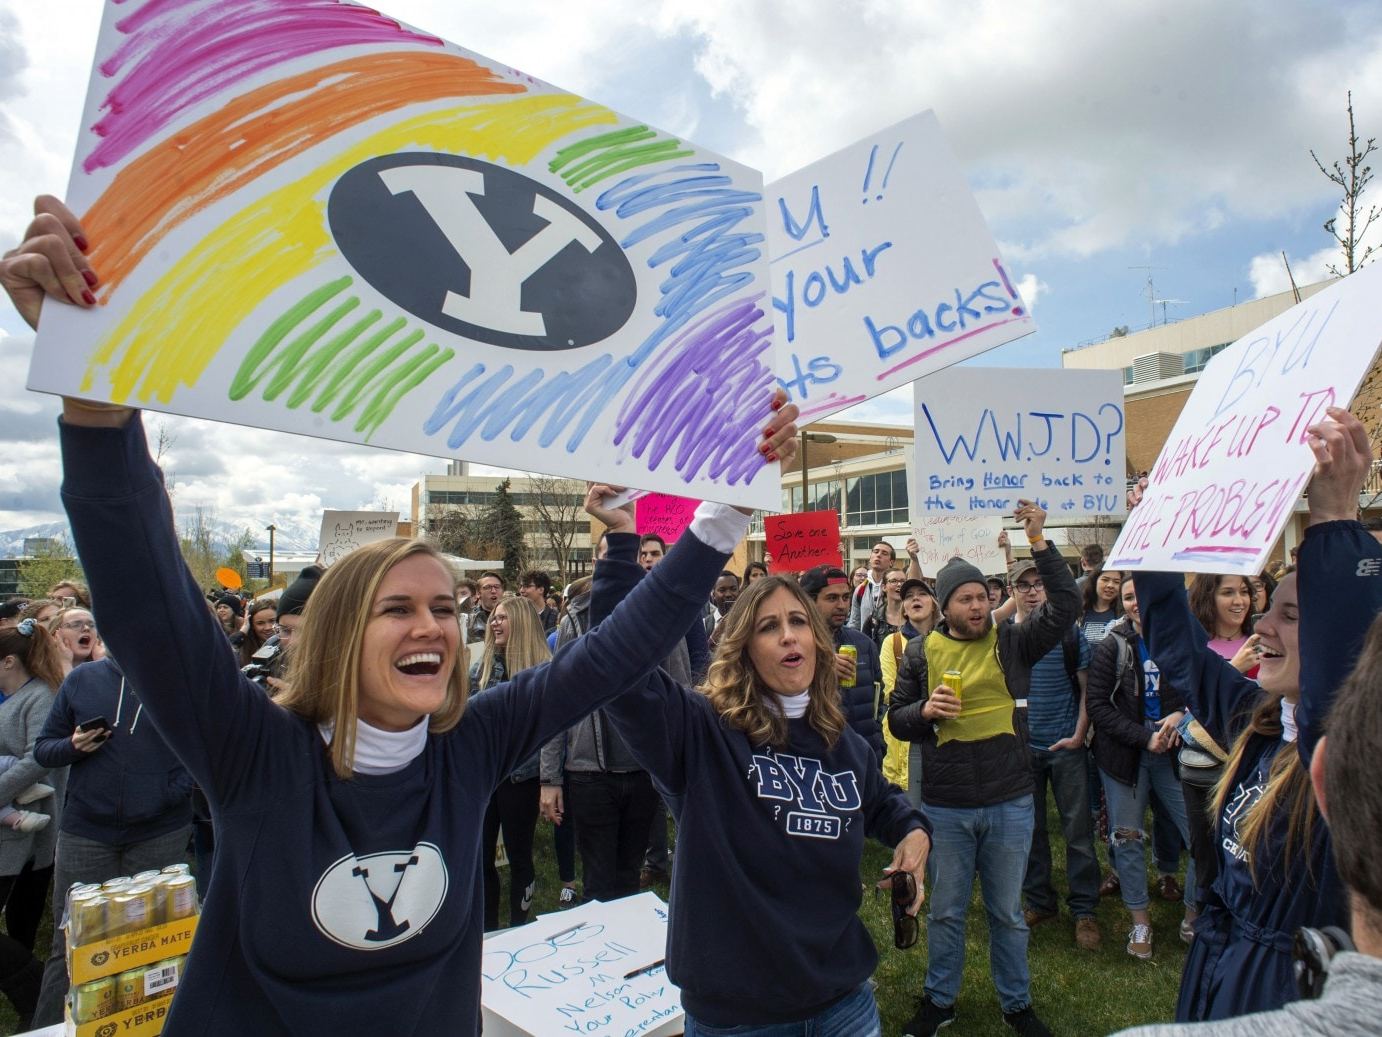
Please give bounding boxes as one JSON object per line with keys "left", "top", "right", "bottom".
{"left": 591, "top": 536, "right": 930, "bottom": 1026}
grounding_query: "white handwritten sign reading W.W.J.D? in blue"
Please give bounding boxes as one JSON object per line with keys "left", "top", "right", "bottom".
{"left": 912, "top": 368, "right": 1126, "bottom": 517}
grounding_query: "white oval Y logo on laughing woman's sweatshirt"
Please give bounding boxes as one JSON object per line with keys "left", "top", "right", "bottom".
{"left": 312, "top": 842, "right": 448, "bottom": 950}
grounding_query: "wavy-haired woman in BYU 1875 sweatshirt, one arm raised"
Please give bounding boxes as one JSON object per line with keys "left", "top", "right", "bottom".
{"left": 591, "top": 522, "right": 930, "bottom": 1037}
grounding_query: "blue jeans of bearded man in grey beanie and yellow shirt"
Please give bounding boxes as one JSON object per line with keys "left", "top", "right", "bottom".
{"left": 925, "top": 795, "right": 1034, "bottom": 1012}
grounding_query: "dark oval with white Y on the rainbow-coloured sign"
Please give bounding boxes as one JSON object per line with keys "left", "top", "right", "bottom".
{"left": 326, "top": 152, "right": 637, "bottom": 350}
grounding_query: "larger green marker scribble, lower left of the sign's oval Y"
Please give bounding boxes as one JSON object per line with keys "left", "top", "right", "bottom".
{"left": 229, "top": 277, "right": 456, "bottom": 442}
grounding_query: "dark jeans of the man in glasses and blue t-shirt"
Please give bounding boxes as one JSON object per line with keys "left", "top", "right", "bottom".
{"left": 1023, "top": 747, "right": 1099, "bottom": 918}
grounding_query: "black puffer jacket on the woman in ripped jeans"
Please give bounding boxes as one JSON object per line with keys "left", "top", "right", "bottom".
{"left": 1085, "top": 617, "right": 1186, "bottom": 785}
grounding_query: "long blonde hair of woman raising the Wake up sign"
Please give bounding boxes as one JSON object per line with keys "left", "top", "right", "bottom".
{"left": 1211, "top": 691, "right": 1316, "bottom": 884}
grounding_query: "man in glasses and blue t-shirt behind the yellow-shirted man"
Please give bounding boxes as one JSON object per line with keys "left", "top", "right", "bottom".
{"left": 1009, "top": 559, "right": 1101, "bottom": 950}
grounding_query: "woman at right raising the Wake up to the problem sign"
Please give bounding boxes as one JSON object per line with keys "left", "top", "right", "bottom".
{"left": 1136, "top": 408, "right": 1382, "bottom": 1020}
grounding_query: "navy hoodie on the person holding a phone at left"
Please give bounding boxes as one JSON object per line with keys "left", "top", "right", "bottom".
{"left": 33, "top": 657, "right": 192, "bottom": 846}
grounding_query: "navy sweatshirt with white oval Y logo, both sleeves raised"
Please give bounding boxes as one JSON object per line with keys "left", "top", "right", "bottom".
{"left": 61, "top": 418, "right": 726, "bottom": 1037}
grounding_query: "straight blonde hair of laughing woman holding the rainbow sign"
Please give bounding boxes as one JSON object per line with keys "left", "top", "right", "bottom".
{"left": 275, "top": 536, "right": 470, "bottom": 778}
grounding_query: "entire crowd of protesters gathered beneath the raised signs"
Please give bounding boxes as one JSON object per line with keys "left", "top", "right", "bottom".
{"left": 0, "top": 206, "right": 1382, "bottom": 1037}
